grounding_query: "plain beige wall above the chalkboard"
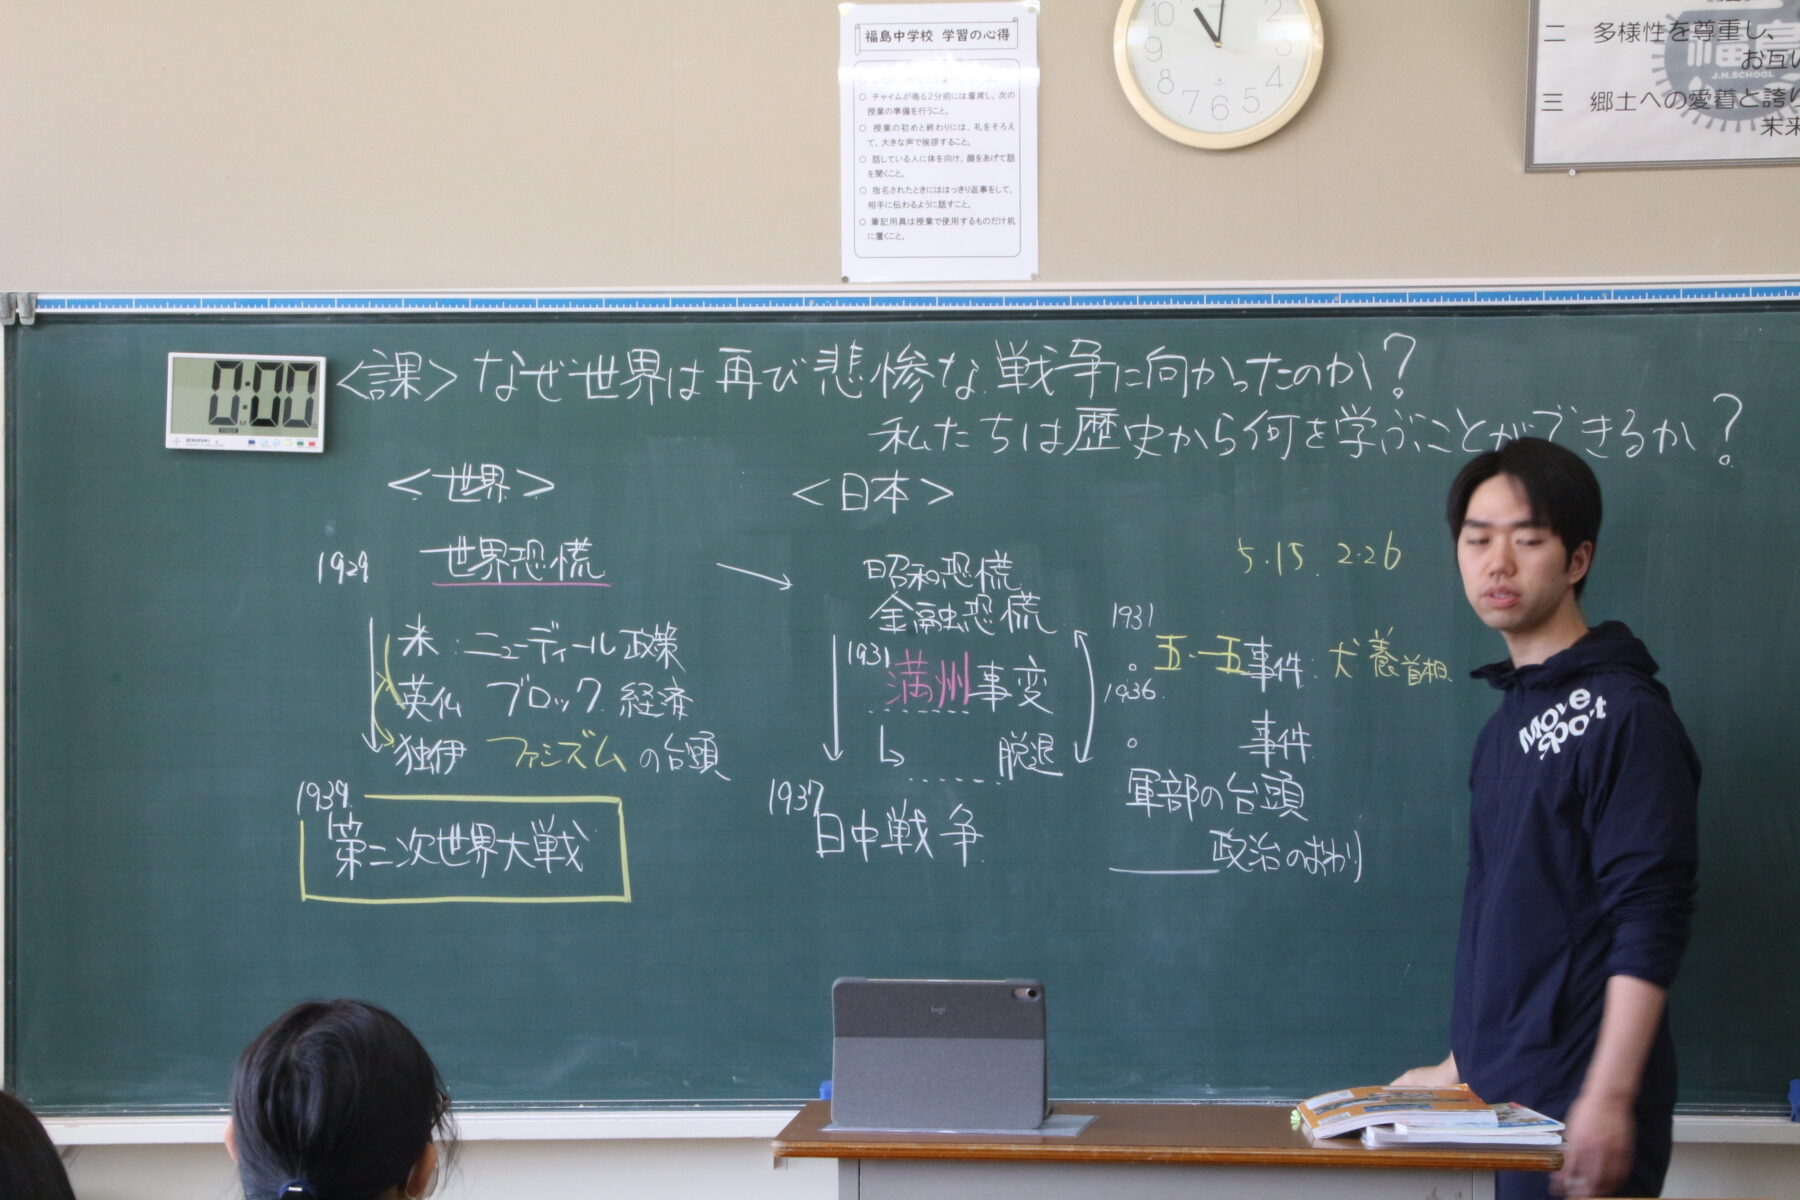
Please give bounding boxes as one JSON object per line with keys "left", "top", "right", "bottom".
{"left": 0, "top": 0, "right": 1800, "bottom": 291}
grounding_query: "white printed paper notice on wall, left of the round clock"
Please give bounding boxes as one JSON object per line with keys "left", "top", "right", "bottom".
{"left": 837, "top": 0, "right": 1039, "bottom": 282}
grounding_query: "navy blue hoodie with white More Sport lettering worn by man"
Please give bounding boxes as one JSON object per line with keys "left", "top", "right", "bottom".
{"left": 1451, "top": 621, "right": 1699, "bottom": 1155}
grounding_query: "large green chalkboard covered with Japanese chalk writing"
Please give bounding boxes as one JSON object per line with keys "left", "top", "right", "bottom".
{"left": 5, "top": 306, "right": 1800, "bottom": 1112}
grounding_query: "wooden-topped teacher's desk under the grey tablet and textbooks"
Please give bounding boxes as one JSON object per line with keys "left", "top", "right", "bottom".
{"left": 774, "top": 1101, "right": 1562, "bottom": 1200}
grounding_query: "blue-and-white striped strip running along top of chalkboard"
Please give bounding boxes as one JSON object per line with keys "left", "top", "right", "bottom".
{"left": 24, "top": 282, "right": 1800, "bottom": 315}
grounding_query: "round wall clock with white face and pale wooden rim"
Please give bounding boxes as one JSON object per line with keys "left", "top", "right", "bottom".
{"left": 1112, "top": 0, "right": 1325, "bottom": 149}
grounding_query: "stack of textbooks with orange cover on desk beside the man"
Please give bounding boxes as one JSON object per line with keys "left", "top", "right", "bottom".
{"left": 1294, "top": 1087, "right": 1562, "bottom": 1146}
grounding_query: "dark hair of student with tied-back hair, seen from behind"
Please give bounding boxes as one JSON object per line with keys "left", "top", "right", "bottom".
{"left": 230, "top": 1000, "right": 450, "bottom": 1200}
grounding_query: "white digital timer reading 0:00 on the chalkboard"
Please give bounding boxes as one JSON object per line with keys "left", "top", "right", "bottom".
{"left": 162, "top": 353, "right": 326, "bottom": 453}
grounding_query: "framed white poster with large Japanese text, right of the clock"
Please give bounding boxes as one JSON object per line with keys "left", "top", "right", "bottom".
{"left": 1525, "top": 0, "right": 1800, "bottom": 171}
